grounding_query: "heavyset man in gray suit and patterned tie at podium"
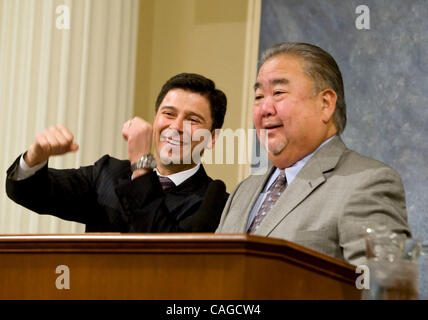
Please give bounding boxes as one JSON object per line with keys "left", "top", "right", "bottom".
{"left": 216, "top": 43, "right": 410, "bottom": 265}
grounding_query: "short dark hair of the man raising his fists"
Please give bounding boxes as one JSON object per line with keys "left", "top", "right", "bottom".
{"left": 155, "top": 73, "right": 227, "bottom": 131}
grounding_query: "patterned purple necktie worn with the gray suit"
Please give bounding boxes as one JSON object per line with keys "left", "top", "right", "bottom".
{"left": 248, "top": 170, "right": 287, "bottom": 233}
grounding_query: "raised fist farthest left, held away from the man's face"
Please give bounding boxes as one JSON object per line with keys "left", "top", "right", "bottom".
{"left": 24, "top": 125, "right": 79, "bottom": 168}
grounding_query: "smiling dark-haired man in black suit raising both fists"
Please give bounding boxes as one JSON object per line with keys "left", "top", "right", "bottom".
{"left": 6, "top": 73, "right": 227, "bottom": 232}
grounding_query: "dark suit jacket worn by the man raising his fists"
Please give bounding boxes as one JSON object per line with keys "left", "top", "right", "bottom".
{"left": 6, "top": 155, "right": 228, "bottom": 232}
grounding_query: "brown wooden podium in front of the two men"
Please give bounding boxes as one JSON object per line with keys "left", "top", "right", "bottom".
{"left": 0, "top": 233, "right": 361, "bottom": 300}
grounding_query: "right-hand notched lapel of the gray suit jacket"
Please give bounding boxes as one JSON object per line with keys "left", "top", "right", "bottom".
{"left": 255, "top": 137, "right": 346, "bottom": 236}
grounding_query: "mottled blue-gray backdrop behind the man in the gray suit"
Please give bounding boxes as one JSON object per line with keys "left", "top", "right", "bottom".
{"left": 259, "top": 0, "right": 428, "bottom": 299}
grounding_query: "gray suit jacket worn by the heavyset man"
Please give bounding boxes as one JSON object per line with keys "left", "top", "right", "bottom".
{"left": 216, "top": 137, "right": 410, "bottom": 265}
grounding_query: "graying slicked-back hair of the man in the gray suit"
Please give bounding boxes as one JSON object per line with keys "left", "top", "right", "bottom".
{"left": 262, "top": 42, "right": 346, "bottom": 133}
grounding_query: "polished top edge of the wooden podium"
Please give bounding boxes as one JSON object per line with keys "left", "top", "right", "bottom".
{"left": 0, "top": 233, "right": 355, "bottom": 272}
